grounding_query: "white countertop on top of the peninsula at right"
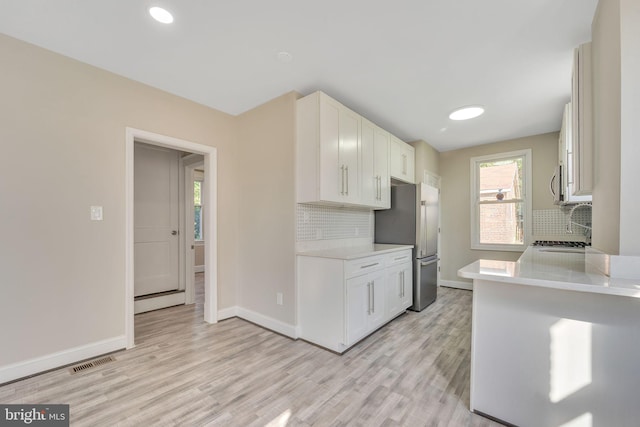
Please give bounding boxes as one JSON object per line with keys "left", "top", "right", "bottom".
{"left": 458, "top": 247, "right": 640, "bottom": 298}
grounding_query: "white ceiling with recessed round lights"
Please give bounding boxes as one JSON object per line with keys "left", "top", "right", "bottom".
{"left": 0, "top": 0, "right": 597, "bottom": 151}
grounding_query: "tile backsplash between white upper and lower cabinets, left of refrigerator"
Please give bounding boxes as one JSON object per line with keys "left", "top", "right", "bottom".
{"left": 296, "top": 204, "right": 373, "bottom": 242}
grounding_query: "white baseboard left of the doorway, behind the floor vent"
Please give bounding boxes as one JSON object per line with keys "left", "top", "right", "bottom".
{"left": 0, "top": 335, "right": 127, "bottom": 384}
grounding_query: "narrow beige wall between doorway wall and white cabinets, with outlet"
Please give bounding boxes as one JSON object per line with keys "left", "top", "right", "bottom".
{"left": 237, "top": 92, "right": 299, "bottom": 326}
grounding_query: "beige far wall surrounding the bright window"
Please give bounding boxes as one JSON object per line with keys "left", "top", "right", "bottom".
{"left": 440, "top": 132, "right": 562, "bottom": 282}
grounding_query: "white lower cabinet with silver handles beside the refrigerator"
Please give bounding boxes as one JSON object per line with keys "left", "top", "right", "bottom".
{"left": 297, "top": 249, "right": 413, "bottom": 353}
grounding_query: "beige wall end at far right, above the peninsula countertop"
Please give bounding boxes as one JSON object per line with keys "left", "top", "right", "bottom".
{"left": 592, "top": 0, "right": 640, "bottom": 256}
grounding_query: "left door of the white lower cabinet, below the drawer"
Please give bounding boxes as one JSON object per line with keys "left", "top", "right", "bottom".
{"left": 346, "top": 275, "right": 371, "bottom": 346}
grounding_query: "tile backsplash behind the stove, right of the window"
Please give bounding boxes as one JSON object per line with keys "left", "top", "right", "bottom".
{"left": 533, "top": 206, "right": 591, "bottom": 240}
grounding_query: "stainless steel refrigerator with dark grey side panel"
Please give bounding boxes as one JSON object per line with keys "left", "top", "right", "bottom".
{"left": 374, "top": 184, "right": 440, "bottom": 311}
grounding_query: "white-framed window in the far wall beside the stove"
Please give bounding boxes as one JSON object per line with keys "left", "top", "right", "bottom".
{"left": 471, "top": 150, "right": 531, "bottom": 251}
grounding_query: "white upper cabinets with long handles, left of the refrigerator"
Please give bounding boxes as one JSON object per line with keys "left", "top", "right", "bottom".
{"left": 296, "top": 92, "right": 398, "bottom": 209}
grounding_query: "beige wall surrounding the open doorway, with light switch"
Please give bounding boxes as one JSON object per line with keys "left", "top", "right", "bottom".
{"left": 0, "top": 35, "right": 239, "bottom": 366}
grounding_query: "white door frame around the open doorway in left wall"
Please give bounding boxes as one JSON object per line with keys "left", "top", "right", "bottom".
{"left": 124, "top": 127, "right": 218, "bottom": 349}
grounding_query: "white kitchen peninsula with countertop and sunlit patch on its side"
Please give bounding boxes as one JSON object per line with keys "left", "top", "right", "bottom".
{"left": 458, "top": 247, "right": 640, "bottom": 427}
